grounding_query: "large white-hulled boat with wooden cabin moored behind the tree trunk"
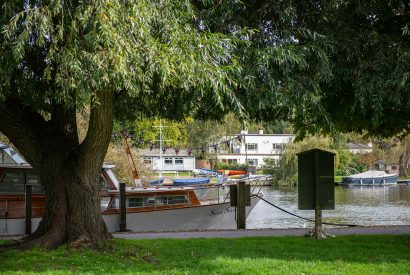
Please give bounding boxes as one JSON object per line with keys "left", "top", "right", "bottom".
{"left": 0, "top": 144, "right": 260, "bottom": 235}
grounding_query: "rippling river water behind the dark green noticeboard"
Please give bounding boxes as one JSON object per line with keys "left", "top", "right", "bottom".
{"left": 246, "top": 185, "right": 410, "bottom": 229}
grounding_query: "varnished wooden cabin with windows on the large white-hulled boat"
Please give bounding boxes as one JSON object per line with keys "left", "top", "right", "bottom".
{"left": 0, "top": 143, "right": 200, "bottom": 221}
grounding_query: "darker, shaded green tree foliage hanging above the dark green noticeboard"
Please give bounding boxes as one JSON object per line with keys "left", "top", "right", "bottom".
{"left": 195, "top": 0, "right": 410, "bottom": 137}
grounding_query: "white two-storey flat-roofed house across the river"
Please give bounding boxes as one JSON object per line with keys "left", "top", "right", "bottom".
{"left": 217, "top": 130, "right": 294, "bottom": 167}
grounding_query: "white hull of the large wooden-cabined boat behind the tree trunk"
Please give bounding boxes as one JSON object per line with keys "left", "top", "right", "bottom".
{"left": 0, "top": 197, "right": 259, "bottom": 235}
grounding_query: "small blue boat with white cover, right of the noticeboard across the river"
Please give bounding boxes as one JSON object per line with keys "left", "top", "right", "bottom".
{"left": 342, "top": 170, "right": 397, "bottom": 185}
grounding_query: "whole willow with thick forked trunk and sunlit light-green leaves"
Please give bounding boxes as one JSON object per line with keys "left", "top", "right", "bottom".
{"left": 0, "top": 0, "right": 241, "bottom": 248}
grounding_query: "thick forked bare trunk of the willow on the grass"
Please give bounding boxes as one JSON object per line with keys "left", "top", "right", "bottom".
{"left": 0, "top": 92, "right": 113, "bottom": 248}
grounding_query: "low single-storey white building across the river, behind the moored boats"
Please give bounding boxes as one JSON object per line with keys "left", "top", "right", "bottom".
{"left": 140, "top": 149, "right": 195, "bottom": 171}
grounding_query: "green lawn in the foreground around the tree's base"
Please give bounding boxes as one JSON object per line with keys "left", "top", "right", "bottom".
{"left": 0, "top": 235, "right": 410, "bottom": 274}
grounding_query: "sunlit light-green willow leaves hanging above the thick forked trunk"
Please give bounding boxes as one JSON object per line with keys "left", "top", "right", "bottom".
{"left": 0, "top": 1, "right": 242, "bottom": 117}
